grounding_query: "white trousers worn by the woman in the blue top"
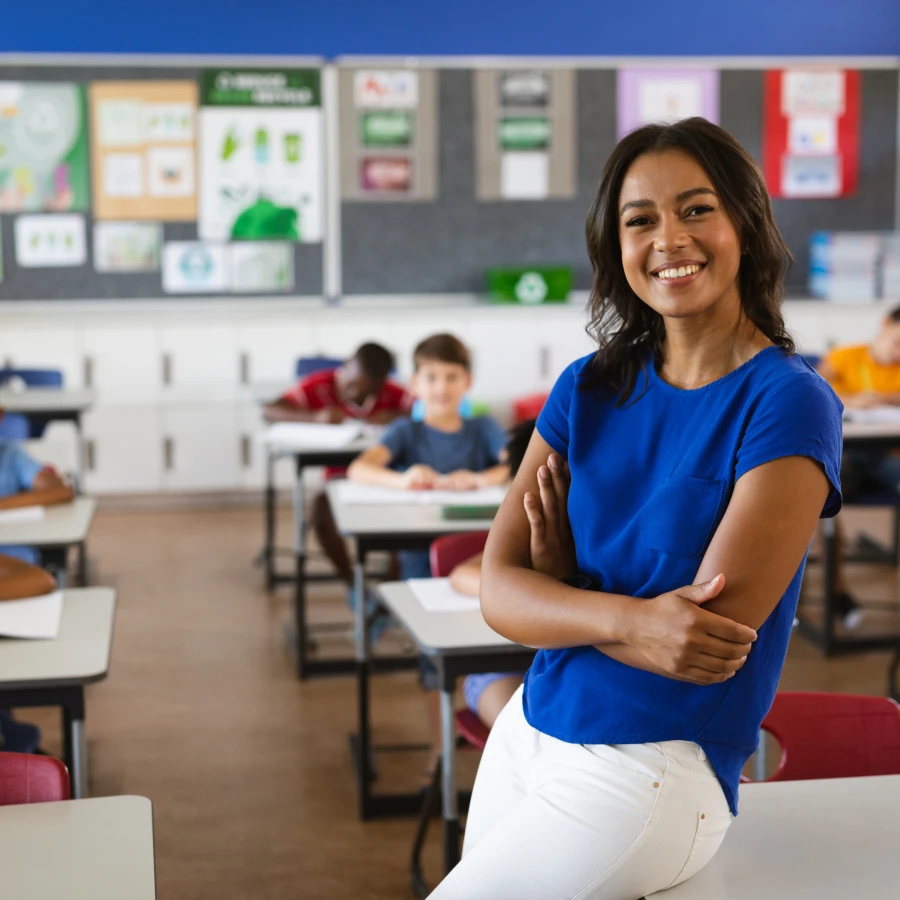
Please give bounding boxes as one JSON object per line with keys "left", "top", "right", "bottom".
{"left": 431, "top": 688, "right": 732, "bottom": 900}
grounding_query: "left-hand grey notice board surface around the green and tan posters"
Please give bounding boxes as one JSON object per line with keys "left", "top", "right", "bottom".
{"left": 0, "top": 64, "right": 323, "bottom": 301}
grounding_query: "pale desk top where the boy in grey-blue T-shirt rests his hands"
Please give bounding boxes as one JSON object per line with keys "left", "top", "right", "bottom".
{"left": 325, "top": 481, "right": 493, "bottom": 537}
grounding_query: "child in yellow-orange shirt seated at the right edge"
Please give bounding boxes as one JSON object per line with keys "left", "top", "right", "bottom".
{"left": 819, "top": 306, "right": 900, "bottom": 628}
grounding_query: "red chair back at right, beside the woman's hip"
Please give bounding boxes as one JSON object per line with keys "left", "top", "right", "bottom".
{"left": 762, "top": 691, "right": 900, "bottom": 781}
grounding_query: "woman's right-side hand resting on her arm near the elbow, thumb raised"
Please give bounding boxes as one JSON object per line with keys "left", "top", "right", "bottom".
{"left": 624, "top": 575, "right": 756, "bottom": 684}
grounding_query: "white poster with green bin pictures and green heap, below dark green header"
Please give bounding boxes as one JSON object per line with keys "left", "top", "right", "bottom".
{"left": 199, "top": 106, "right": 323, "bottom": 243}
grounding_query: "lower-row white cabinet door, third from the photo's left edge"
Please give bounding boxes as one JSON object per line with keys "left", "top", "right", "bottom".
{"left": 161, "top": 403, "right": 242, "bottom": 491}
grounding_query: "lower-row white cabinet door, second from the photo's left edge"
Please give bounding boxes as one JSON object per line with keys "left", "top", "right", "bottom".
{"left": 84, "top": 406, "right": 163, "bottom": 494}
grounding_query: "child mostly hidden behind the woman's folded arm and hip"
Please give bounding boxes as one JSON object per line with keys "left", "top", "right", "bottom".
{"left": 450, "top": 419, "right": 540, "bottom": 728}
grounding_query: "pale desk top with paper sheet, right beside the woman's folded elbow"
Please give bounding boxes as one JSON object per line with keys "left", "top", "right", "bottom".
{"left": 376, "top": 581, "right": 522, "bottom": 654}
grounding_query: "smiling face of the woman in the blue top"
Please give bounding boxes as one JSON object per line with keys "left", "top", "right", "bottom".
{"left": 619, "top": 150, "right": 741, "bottom": 318}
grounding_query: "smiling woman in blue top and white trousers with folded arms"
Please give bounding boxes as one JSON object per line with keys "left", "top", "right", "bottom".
{"left": 433, "top": 119, "right": 841, "bottom": 900}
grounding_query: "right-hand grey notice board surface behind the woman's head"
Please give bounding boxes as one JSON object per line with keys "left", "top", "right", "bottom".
{"left": 341, "top": 69, "right": 898, "bottom": 295}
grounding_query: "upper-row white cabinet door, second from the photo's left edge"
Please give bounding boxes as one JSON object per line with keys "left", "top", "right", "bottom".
{"left": 83, "top": 323, "right": 162, "bottom": 405}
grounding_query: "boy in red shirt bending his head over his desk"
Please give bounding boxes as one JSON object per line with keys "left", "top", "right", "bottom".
{"left": 263, "top": 343, "right": 412, "bottom": 589}
